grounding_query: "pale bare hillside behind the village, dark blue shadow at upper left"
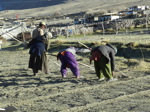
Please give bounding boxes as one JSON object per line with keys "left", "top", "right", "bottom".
{"left": 0, "top": 0, "right": 150, "bottom": 18}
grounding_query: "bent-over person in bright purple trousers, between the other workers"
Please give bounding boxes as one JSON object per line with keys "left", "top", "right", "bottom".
{"left": 57, "top": 47, "right": 80, "bottom": 79}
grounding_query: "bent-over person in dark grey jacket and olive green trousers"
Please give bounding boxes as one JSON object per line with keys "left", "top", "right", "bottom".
{"left": 90, "top": 43, "right": 117, "bottom": 81}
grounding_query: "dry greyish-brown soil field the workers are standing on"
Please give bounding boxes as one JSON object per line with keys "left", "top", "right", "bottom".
{"left": 0, "top": 35, "right": 150, "bottom": 112}
